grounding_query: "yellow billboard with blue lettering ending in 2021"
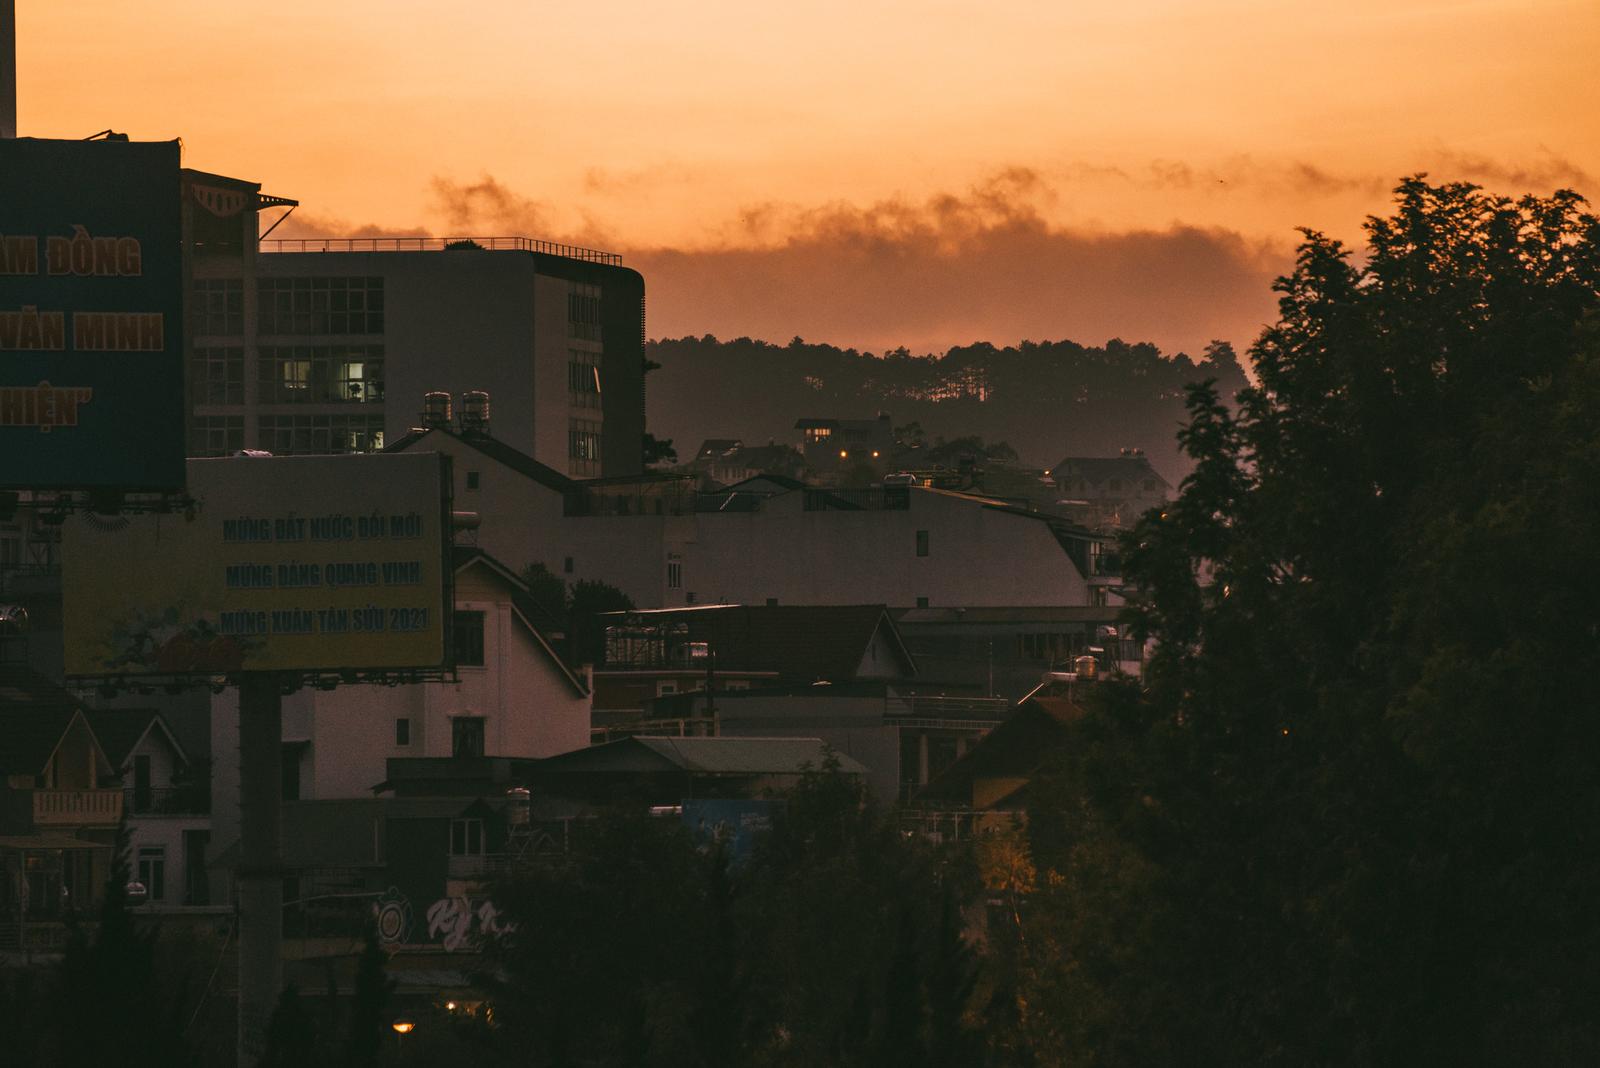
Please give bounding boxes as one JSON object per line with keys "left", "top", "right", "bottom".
{"left": 61, "top": 452, "right": 453, "bottom": 678}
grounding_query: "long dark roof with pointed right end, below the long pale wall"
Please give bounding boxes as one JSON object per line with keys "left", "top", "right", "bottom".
{"left": 605, "top": 604, "right": 917, "bottom": 683}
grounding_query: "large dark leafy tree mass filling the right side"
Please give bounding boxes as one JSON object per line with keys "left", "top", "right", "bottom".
{"left": 1022, "top": 179, "right": 1600, "bottom": 1065}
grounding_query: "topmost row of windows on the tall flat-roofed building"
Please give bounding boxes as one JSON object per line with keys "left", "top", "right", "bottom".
{"left": 190, "top": 277, "right": 384, "bottom": 337}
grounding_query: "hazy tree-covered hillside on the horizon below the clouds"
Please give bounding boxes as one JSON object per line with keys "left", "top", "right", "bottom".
{"left": 646, "top": 334, "right": 1248, "bottom": 483}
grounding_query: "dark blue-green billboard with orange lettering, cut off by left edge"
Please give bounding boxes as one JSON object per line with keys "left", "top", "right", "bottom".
{"left": 0, "top": 137, "right": 184, "bottom": 489}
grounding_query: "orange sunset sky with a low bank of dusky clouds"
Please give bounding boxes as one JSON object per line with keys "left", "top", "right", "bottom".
{"left": 18, "top": 0, "right": 1600, "bottom": 352}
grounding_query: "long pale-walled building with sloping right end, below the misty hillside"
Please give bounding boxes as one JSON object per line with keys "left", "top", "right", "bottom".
{"left": 390, "top": 428, "right": 1118, "bottom": 608}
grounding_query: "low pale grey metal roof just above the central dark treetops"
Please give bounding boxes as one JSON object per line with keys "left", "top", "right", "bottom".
{"left": 534, "top": 735, "right": 867, "bottom": 775}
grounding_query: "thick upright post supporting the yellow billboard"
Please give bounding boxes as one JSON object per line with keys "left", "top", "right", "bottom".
{"left": 238, "top": 671, "right": 283, "bottom": 1065}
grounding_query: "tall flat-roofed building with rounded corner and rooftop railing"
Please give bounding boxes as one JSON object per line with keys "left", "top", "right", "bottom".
{"left": 182, "top": 171, "right": 645, "bottom": 476}
